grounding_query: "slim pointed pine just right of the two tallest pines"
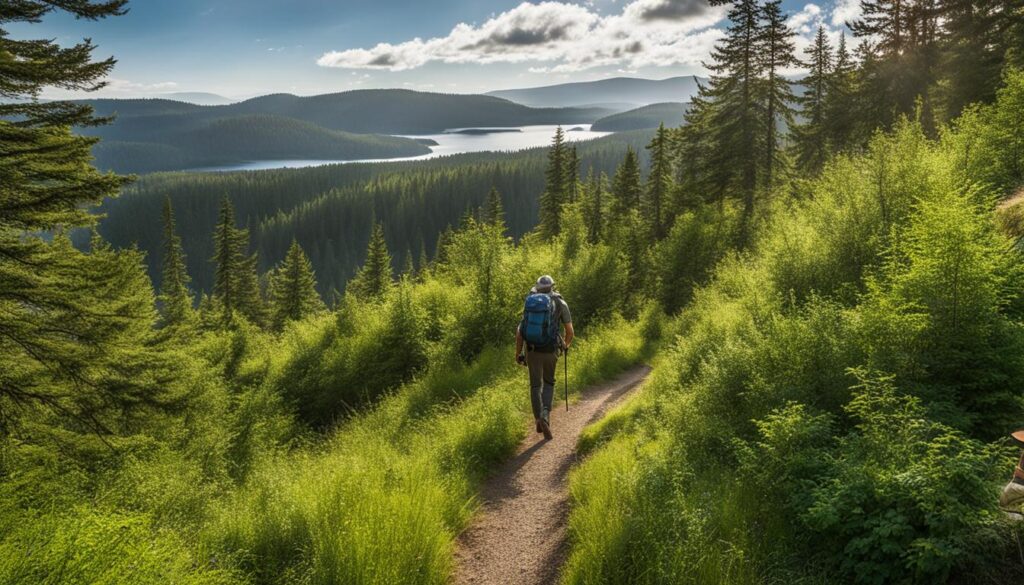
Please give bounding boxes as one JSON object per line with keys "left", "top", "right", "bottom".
{"left": 793, "top": 26, "right": 831, "bottom": 174}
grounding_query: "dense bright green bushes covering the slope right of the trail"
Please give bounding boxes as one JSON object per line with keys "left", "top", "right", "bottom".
{"left": 563, "top": 99, "right": 1024, "bottom": 583}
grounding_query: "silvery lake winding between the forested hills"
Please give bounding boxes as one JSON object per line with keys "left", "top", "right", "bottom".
{"left": 188, "top": 124, "right": 611, "bottom": 172}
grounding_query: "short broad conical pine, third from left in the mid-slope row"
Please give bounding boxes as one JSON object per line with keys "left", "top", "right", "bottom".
{"left": 269, "top": 240, "right": 325, "bottom": 331}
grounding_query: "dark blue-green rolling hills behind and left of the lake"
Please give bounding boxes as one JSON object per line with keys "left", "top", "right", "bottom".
{"left": 81, "top": 89, "right": 611, "bottom": 172}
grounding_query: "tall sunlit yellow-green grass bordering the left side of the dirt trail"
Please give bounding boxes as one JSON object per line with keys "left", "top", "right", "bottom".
{"left": 202, "top": 320, "right": 645, "bottom": 585}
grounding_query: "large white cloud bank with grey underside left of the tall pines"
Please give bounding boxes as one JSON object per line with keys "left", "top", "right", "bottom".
{"left": 316, "top": 0, "right": 726, "bottom": 73}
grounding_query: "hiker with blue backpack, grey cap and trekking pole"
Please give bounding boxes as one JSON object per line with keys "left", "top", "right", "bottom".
{"left": 515, "top": 275, "right": 574, "bottom": 440}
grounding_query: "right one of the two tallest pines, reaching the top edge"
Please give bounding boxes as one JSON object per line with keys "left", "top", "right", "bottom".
{"left": 760, "top": 0, "right": 797, "bottom": 191}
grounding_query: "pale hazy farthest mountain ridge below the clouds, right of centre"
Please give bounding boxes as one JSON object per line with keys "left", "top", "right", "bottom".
{"left": 486, "top": 75, "right": 707, "bottom": 108}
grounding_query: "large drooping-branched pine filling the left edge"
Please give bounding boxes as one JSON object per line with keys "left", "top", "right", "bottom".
{"left": 0, "top": 0, "right": 178, "bottom": 434}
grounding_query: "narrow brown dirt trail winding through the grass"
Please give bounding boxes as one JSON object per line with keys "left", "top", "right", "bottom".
{"left": 455, "top": 366, "right": 650, "bottom": 585}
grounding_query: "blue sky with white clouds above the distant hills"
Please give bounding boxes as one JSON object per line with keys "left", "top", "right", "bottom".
{"left": 16, "top": 0, "right": 857, "bottom": 97}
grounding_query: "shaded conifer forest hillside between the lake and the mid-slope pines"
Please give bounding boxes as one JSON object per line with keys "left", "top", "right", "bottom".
{"left": 88, "top": 132, "right": 649, "bottom": 298}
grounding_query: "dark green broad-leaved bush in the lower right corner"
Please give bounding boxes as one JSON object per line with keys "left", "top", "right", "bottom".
{"left": 805, "top": 374, "right": 1009, "bottom": 583}
